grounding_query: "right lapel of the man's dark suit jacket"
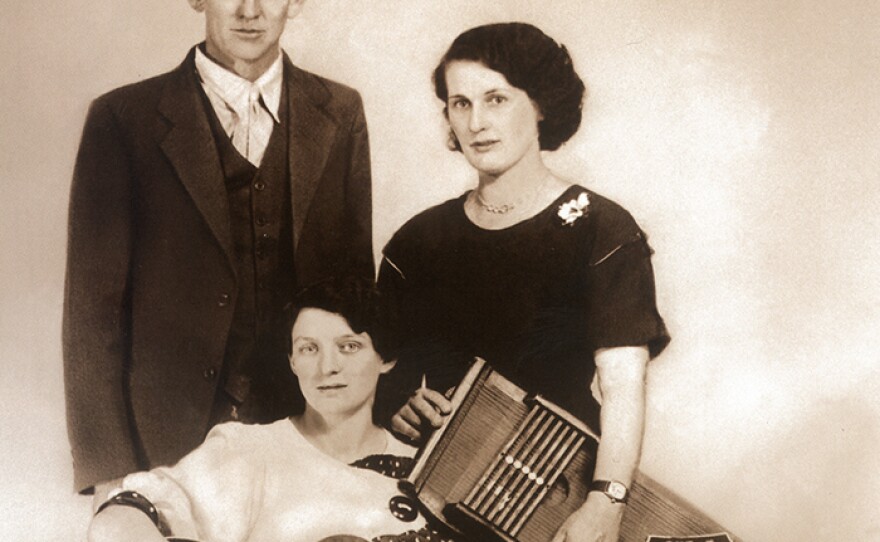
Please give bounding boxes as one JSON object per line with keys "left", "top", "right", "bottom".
{"left": 284, "top": 55, "right": 337, "bottom": 250}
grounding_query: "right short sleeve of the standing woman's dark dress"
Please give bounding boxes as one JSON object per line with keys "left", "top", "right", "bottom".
{"left": 587, "top": 215, "right": 670, "bottom": 358}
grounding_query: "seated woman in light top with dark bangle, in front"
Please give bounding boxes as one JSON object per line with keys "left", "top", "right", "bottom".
{"left": 89, "top": 279, "right": 439, "bottom": 542}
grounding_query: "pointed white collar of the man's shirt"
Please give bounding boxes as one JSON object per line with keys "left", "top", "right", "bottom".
{"left": 196, "top": 47, "right": 284, "bottom": 122}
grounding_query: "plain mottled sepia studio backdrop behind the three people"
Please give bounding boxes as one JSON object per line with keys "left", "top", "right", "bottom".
{"left": 0, "top": 0, "right": 880, "bottom": 542}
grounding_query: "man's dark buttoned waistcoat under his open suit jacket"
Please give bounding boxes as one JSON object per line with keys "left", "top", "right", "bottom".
{"left": 203, "top": 87, "right": 295, "bottom": 404}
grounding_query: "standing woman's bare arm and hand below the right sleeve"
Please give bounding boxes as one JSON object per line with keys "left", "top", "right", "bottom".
{"left": 553, "top": 347, "right": 648, "bottom": 542}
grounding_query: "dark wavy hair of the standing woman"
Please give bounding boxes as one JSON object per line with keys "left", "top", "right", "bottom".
{"left": 434, "top": 23, "right": 585, "bottom": 151}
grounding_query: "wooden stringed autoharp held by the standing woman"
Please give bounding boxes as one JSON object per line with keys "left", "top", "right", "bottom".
{"left": 401, "top": 359, "right": 731, "bottom": 542}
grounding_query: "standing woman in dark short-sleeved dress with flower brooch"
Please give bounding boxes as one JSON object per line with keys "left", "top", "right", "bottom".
{"left": 379, "top": 23, "right": 669, "bottom": 542}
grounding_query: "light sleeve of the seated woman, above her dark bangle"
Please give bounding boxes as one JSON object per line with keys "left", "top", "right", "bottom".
{"left": 123, "top": 423, "right": 265, "bottom": 541}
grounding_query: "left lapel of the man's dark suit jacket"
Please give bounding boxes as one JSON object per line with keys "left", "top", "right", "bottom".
{"left": 159, "top": 48, "right": 235, "bottom": 270}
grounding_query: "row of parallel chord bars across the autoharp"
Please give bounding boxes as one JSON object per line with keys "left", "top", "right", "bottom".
{"left": 462, "top": 403, "right": 586, "bottom": 536}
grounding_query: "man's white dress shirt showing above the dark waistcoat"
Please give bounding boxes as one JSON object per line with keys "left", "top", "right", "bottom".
{"left": 196, "top": 47, "right": 284, "bottom": 167}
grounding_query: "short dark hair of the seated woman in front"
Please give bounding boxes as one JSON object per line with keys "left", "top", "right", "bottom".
{"left": 286, "top": 277, "right": 398, "bottom": 362}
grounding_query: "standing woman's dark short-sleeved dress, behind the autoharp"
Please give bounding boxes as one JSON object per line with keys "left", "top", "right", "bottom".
{"left": 379, "top": 185, "right": 669, "bottom": 432}
